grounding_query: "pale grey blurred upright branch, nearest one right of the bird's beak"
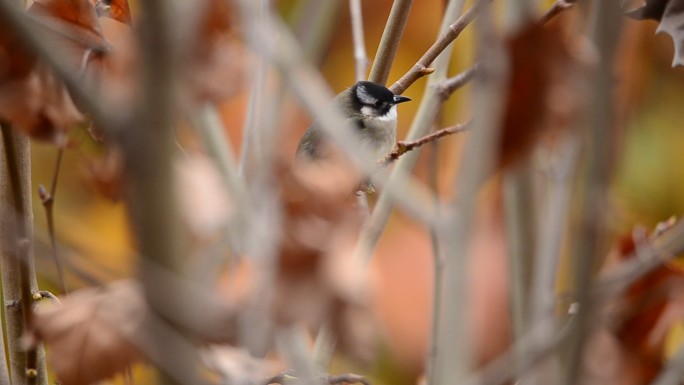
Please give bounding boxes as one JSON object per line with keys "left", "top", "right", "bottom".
{"left": 429, "top": 9, "right": 506, "bottom": 385}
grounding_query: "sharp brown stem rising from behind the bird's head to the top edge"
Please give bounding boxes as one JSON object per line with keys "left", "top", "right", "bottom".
{"left": 368, "top": 0, "right": 413, "bottom": 84}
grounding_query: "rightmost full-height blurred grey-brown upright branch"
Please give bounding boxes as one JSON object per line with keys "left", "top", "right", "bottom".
{"left": 564, "top": 1, "right": 621, "bottom": 384}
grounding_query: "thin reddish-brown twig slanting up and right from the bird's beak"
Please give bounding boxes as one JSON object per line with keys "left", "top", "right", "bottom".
{"left": 390, "top": 0, "right": 491, "bottom": 94}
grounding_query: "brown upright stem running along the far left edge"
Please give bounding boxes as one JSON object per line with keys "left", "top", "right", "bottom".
{"left": 0, "top": 122, "right": 47, "bottom": 385}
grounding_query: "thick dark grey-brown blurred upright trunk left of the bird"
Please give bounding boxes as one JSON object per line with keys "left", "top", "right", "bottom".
{"left": 119, "top": 0, "right": 199, "bottom": 384}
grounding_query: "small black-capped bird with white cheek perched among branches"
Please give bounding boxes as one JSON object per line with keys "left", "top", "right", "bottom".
{"left": 297, "top": 81, "right": 411, "bottom": 164}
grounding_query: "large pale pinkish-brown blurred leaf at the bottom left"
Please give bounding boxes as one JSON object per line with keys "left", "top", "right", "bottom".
{"left": 35, "top": 281, "right": 148, "bottom": 385}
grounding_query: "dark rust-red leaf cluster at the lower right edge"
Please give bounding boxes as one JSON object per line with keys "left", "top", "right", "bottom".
{"left": 585, "top": 220, "right": 684, "bottom": 384}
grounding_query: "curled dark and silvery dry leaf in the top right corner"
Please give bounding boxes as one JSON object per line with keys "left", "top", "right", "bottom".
{"left": 625, "top": 0, "right": 684, "bottom": 67}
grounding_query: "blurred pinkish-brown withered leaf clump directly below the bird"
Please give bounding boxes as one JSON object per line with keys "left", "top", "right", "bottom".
{"left": 273, "top": 157, "right": 372, "bottom": 360}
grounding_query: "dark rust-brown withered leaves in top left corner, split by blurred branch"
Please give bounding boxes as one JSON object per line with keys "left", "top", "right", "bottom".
{"left": 0, "top": 0, "right": 108, "bottom": 145}
